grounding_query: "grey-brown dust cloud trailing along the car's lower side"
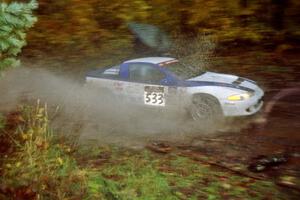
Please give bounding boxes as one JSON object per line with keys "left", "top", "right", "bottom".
{"left": 0, "top": 67, "right": 239, "bottom": 145}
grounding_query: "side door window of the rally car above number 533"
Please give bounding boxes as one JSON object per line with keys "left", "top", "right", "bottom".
{"left": 129, "top": 63, "right": 165, "bottom": 84}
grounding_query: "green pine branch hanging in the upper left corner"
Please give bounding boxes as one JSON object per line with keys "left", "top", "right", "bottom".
{"left": 0, "top": 0, "right": 38, "bottom": 72}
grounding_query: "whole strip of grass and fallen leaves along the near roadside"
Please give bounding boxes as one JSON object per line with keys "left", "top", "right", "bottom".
{"left": 0, "top": 103, "right": 289, "bottom": 200}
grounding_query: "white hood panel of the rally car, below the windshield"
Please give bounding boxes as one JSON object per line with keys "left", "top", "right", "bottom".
{"left": 189, "top": 72, "right": 238, "bottom": 84}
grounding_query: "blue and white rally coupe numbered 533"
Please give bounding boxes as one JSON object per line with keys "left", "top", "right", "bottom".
{"left": 86, "top": 57, "right": 264, "bottom": 119}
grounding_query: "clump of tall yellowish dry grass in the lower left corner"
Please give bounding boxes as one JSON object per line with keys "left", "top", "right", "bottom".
{"left": 0, "top": 102, "right": 86, "bottom": 199}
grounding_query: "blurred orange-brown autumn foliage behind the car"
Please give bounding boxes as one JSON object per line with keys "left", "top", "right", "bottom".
{"left": 27, "top": 0, "right": 300, "bottom": 55}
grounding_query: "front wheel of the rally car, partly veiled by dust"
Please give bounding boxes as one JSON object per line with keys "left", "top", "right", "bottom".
{"left": 190, "top": 94, "right": 223, "bottom": 123}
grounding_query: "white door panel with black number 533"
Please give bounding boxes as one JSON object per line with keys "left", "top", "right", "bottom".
{"left": 144, "top": 86, "right": 166, "bottom": 106}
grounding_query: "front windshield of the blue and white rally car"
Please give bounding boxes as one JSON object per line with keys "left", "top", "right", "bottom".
{"left": 160, "top": 60, "right": 205, "bottom": 80}
